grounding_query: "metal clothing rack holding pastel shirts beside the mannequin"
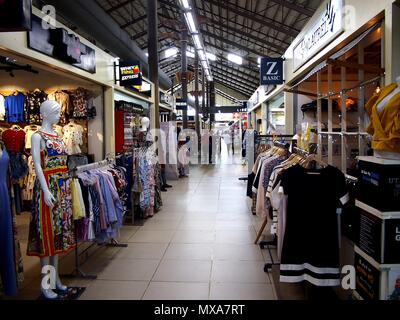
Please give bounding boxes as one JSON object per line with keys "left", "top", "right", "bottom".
{"left": 62, "top": 158, "right": 128, "bottom": 280}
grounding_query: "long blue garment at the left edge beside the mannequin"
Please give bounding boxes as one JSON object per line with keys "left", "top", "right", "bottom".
{"left": 0, "top": 148, "right": 17, "bottom": 296}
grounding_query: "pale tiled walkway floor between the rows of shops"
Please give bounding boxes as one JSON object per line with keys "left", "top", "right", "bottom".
{"left": 12, "top": 164, "right": 276, "bottom": 300}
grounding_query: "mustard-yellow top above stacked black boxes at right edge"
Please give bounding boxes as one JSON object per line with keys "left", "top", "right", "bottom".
{"left": 365, "top": 83, "right": 400, "bottom": 153}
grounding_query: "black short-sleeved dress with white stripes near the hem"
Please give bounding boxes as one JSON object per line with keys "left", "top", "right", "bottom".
{"left": 280, "top": 165, "right": 348, "bottom": 286}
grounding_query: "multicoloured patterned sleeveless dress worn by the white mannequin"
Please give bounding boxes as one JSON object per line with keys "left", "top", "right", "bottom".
{"left": 27, "top": 131, "right": 76, "bottom": 257}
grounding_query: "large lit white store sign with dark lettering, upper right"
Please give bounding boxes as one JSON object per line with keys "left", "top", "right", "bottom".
{"left": 293, "top": 0, "right": 344, "bottom": 71}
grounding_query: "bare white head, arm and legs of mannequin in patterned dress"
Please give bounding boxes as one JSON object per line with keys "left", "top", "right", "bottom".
{"left": 31, "top": 101, "right": 68, "bottom": 299}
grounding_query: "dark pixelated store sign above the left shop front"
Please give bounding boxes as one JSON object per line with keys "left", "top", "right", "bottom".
{"left": 28, "top": 16, "right": 96, "bottom": 74}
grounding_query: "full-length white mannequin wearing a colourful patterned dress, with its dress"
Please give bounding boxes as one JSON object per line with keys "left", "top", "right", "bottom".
{"left": 27, "top": 100, "right": 75, "bottom": 300}
